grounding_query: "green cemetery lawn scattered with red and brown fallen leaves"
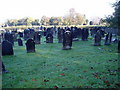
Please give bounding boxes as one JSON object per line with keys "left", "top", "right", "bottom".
{"left": 2, "top": 38, "right": 120, "bottom": 88}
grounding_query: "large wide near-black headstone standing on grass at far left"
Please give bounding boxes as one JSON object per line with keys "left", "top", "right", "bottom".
{"left": 2, "top": 40, "right": 14, "bottom": 56}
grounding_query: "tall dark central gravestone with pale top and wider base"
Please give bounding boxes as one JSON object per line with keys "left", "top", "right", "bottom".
{"left": 62, "top": 30, "right": 72, "bottom": 50}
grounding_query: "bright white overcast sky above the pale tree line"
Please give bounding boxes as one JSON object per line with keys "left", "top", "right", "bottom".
{"left": 0, "top": 0, "right": 116, "bottom": 23}
